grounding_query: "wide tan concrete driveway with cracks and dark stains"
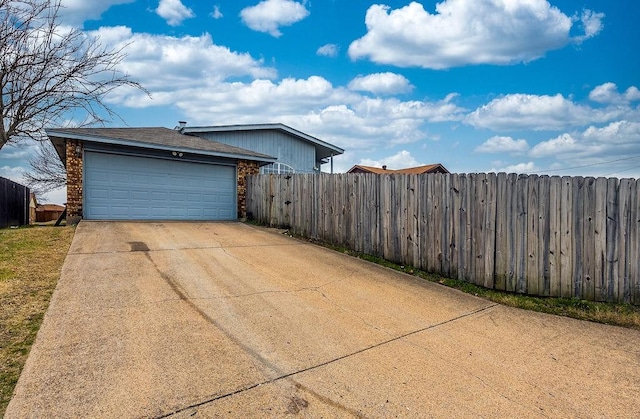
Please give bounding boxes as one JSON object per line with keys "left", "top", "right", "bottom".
{"left": 6, "top": 222, "right": 640, "bottom": 418}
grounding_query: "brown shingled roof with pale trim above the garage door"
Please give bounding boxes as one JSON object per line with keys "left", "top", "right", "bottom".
{"left": 45, "top": 127, "right": 277, "bottom": 164}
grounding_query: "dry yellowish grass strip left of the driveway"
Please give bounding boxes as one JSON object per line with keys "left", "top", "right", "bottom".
{"left": 0, "top": 227, "right": 75, "bottom": 417}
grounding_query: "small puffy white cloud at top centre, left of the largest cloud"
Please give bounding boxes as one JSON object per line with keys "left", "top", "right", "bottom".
{"left": 240, "top": 0, "right": 309, "bottom": 38}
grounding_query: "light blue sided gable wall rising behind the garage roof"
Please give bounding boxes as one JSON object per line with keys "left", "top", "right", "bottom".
{"left": 197, "top": 130, "right": 317, "bottom": 173}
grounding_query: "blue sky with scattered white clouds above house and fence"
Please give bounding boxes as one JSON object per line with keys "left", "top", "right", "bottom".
{"left": 0, "top": 0, "right": 640, "bottom": 202}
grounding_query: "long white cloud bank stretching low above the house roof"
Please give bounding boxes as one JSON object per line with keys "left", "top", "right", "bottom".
{"left": 81, "top": 26, "right": 467, "bottom": 161}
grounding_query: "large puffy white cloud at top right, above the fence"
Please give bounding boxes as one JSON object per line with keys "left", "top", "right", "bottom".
{"left": 349, "top": 0, "right": 603, "bottom": 69}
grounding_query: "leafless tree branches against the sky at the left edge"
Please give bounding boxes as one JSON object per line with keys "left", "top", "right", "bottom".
{"left": 0, "top": 0, "right": 149, "bottom": 195}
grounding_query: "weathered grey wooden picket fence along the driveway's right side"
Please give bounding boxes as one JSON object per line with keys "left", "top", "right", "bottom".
{"left": 247, "top": 173, "right": 640, "bottom": 304}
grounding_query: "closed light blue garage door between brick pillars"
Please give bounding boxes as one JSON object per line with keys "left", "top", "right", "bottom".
{"left": 84, "top": 151, "right": 237, "bottom": 220}
